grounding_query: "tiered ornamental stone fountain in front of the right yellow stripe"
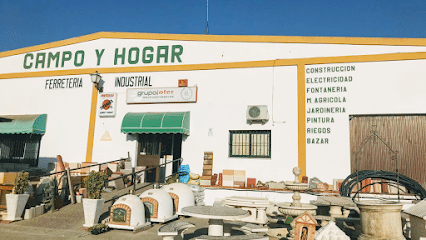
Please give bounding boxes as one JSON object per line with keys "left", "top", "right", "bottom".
{"left": 277, "top": 167, "right": 317, "bottom": 239}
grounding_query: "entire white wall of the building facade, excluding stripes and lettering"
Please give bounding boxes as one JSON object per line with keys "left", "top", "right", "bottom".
{"left": 0, "top": 34, "right": 426, "bottom": 183}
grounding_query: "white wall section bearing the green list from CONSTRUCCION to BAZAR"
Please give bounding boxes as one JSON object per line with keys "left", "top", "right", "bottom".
{"left": 306, "top": 60, "right": 426, "bottom": 183}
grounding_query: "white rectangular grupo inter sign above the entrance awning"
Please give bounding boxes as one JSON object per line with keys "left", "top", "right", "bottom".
{"left": 126, "top": 87, "right": 197, "bottom": 103}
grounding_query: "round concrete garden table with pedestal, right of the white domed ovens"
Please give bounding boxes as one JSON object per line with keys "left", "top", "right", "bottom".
{"left": 182, "top": 206, "right": 249, "bottom": 236}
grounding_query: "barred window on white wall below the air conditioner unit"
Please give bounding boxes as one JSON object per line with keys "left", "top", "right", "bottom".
{"left": 229, "top": 130, "right": 271, "bottom": 158}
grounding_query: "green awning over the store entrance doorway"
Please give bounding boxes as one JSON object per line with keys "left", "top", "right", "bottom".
{"left": 121, "top": 112, "right": 189, "bottom": 135}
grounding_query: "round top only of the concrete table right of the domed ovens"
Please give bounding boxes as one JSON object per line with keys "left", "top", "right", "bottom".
{"left": 181, "top": 206, "right": 249, "bottom": 220}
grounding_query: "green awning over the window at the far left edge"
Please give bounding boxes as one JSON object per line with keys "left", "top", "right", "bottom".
{"left": 0, "top": 114, "right": 47, "bottom": 135}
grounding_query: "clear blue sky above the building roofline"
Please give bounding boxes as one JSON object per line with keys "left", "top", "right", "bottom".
{"left": 0, "top": 0, "right": 426, "bottom": 52}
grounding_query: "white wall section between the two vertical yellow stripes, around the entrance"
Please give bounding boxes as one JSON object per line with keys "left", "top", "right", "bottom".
{"left": 93, "top": 66, "right": 298, "bottom": 181}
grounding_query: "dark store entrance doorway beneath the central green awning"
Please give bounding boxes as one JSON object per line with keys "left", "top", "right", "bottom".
{"left": 137, "top": 133, "right": 182, "bottom": 182}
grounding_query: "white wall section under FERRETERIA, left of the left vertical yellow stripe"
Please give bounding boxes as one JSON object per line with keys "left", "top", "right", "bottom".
{"left": 0, "top": 75, "right": 92, "bottom": 167}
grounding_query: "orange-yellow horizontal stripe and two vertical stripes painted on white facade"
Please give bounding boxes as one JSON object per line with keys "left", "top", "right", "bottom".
{"left": 0, "top": 47, "right": 426, "bottom": 172}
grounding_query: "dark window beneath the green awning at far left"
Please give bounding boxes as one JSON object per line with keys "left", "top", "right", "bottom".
{"left": 0, "top": 134, "right": 41, "bottom": 167}
